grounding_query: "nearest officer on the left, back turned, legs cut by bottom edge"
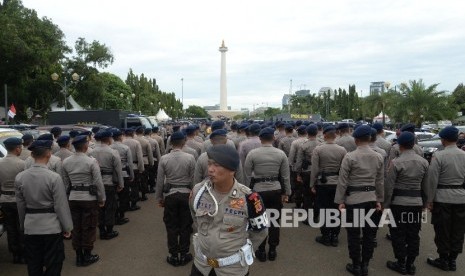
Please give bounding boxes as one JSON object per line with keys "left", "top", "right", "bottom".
{"left": 15, "top": 141, "right": 73, "bottom": 276}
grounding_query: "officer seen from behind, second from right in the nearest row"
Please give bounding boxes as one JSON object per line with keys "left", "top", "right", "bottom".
{"left": 384, "top": 132, "right": 429, "bottom": 275}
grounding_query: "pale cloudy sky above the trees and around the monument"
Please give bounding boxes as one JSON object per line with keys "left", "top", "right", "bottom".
{"left": 23, "top": 0, "right": 465, "bottom": 109}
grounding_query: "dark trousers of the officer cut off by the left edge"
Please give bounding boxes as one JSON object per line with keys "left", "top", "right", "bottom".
{"left": 2, "top": 202, "right": 24, "bottom": 255}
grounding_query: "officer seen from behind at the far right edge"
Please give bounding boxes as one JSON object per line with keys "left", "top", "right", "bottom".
{"left": 427, "top": 126, "right": 465, "bottom": 271}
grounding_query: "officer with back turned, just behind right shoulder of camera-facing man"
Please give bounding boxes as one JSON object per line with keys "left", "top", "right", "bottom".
{"left": 244, "top": 127, "right": 291, "bottom": 262}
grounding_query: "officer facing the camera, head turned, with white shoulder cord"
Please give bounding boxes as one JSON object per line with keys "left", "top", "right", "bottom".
{"left": 189, "top": 145, "right": 268, "bottom": 276}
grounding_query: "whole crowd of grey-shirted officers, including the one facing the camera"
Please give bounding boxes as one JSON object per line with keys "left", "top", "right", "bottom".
{"left": 0, "top": 121, "right": 465, "bottom": 276}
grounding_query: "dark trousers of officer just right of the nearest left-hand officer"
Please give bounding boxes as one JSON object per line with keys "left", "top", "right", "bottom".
{"left": 69, "top": 200, "right": 99, "bottom": 250}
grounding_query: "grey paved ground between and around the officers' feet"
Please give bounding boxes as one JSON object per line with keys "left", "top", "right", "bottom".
{"left": 0, "top": 195, "right": 465, "bottom": 276}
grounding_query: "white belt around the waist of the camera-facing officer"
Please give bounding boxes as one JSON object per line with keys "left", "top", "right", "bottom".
{"left": 193, "top": 233, "right": 253, "bottom": 268}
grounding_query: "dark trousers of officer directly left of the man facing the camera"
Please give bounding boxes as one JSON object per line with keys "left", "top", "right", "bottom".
{"left": 163, "top": 193, "right": 193, "bottom": 255}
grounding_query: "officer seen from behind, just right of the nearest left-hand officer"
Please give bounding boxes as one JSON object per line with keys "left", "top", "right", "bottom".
{"left": 63, "top": 135, "right": 105, "bottom": 266}
